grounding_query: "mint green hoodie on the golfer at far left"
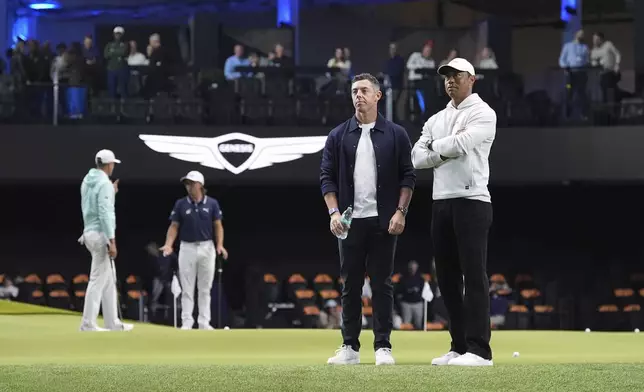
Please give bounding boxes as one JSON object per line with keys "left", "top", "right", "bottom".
{"left": 81, "top": 169, "right": 116, "bottom": 239}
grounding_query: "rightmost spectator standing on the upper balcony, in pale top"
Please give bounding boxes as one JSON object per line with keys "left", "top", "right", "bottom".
{"left": 590, "top": 31, "right": 622, "bottom": 103}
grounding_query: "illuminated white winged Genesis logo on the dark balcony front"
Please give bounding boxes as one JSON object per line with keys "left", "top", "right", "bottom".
{"left": 139, "top": 133, "right": 327, "bottom": 174}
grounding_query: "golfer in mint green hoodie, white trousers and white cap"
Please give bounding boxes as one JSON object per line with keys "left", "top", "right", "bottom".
{"left": 78, "top": 150, "right": 133, "bottom": 331}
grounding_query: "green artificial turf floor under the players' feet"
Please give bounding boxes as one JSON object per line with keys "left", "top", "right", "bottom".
{"left": 0, "top": 300, "right": 644, "bottom": 392}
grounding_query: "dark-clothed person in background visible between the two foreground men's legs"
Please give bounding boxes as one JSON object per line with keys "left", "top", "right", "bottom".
{"left": 398, "top": 260, "right": 425, "bottom": 329}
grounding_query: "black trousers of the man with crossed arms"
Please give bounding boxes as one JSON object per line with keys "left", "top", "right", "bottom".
{"left": 432, "top": 199, "right": 492, "bottom": 359}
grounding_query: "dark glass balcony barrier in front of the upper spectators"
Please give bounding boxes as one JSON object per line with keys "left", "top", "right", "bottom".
{"left": 0, "top": 67, "right": 644, "bottom": 127}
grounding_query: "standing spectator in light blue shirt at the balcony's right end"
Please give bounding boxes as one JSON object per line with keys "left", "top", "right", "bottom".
{"left": 559, "top": 30, "right": 589, "bottom": 118}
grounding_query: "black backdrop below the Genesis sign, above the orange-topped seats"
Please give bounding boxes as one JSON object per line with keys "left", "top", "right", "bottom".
{"left": 5, "top": 182, "right": 644, "bottom": 309}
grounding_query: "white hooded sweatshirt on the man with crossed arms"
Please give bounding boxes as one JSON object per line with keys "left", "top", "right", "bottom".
{"left": 411, "top": 94, "right": 496, "bottom": 202}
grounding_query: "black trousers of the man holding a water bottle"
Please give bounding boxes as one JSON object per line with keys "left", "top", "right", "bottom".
{"left": 339, "top": 217, "right": 397, "bottom": 351}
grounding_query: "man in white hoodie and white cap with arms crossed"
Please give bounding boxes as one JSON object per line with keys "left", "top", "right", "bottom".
{"left": 412, "top": 58, "right": 496, "bottom": 366}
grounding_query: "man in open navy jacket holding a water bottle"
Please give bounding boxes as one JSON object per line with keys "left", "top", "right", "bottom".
{"left": 320, "top": 74, "right": 416, "bottom": 365}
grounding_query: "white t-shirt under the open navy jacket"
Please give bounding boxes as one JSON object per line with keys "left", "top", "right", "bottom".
{"left": 353, "top": 122, "right": 378, "bottom": 218}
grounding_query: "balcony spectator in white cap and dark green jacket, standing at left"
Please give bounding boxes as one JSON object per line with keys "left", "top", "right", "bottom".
{"left": 103, "top": 26, "right": 128, "bottom": 98}
